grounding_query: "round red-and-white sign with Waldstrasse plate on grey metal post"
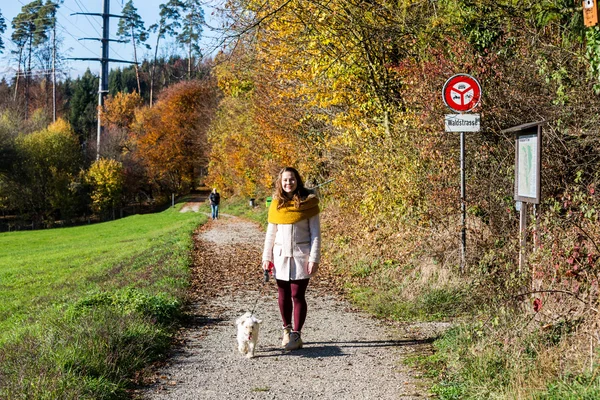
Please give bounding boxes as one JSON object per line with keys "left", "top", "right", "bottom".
{"left": 442, "top": 74, "right": 481, "bottom": 273}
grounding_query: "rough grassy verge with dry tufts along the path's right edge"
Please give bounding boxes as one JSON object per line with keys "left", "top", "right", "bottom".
{"left": 337, "top": 258, "right": 600, "bottom": 400}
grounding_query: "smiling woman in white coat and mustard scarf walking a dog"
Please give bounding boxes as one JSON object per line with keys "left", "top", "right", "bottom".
{"left": 262, "top": 167, "right": 321, "bottom": 350}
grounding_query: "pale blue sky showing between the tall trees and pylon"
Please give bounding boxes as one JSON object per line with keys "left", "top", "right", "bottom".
{"left": 0, "top": 0, "right": 222, "bottom": 79}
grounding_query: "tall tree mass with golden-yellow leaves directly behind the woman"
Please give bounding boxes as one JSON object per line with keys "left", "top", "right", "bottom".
{"left": 209, "top": 0, "right": 450, "bottom": 233}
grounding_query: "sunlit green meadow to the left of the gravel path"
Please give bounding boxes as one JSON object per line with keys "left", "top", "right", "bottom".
{"left": 0, "top": 207, "right": 205, "bottom": 399}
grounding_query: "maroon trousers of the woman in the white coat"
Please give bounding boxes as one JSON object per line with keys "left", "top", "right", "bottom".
{"left": 277, "top": 279, "right": 309, "bottom": 332}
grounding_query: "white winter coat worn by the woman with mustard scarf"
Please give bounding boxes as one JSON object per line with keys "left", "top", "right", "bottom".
{"left": 262, "top": 214, "right": 321, "bottom": 281}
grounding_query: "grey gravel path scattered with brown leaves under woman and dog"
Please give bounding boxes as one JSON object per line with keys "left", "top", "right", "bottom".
{"left": 138, "top": 211, "right": 443, "bottom": 400}
